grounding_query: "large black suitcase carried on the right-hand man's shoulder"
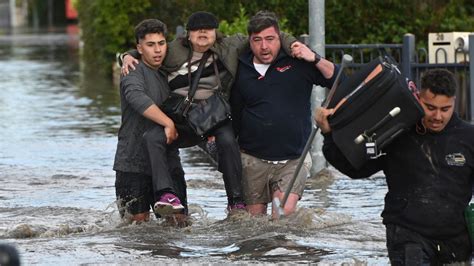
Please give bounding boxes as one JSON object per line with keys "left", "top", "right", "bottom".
{"left": 328, "top": 57, "right": 424, "bottom": 169}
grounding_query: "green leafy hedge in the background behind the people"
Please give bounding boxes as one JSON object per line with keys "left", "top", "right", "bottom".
{"left": 75, "top": 0, "right": 474, "bottom": 77}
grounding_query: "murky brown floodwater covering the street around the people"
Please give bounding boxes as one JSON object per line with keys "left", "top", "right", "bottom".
{"left": 0, "top": 28, "right": 388, "bottom": 265}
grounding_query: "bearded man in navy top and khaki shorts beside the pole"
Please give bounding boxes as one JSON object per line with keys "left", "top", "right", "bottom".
{"left": 231, "top": 11, "right": 335, "bottom": 217}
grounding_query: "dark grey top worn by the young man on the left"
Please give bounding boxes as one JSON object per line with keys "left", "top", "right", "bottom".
{"left": 113, "top": 61, "right": 169, "bottom": 174}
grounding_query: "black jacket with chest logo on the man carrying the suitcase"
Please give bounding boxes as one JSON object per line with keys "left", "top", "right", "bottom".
{"left": 323, "top": 114, "right": 474, "bottom": 240}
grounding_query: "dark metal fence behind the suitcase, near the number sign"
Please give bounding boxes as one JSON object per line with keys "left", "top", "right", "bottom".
{"left": 320, "top": 34, "right": 474, "bottom": 122}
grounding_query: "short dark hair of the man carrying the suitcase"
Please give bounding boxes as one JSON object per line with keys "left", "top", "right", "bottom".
{"left": 420, "top": 68, "right": 458, "bottom": 97}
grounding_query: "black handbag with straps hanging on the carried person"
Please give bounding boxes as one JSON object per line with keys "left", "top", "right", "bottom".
{"left": 161, "top": 51, "right": 231, "bottom": 138}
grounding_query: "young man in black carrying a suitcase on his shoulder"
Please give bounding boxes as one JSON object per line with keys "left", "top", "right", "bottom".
{"left": 315, "top": 69, "right": 474, "bottom": 265}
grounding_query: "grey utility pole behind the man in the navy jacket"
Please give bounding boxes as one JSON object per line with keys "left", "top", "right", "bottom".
{"left": 308, "top": 0, "right": 327, "bottom": 176}
